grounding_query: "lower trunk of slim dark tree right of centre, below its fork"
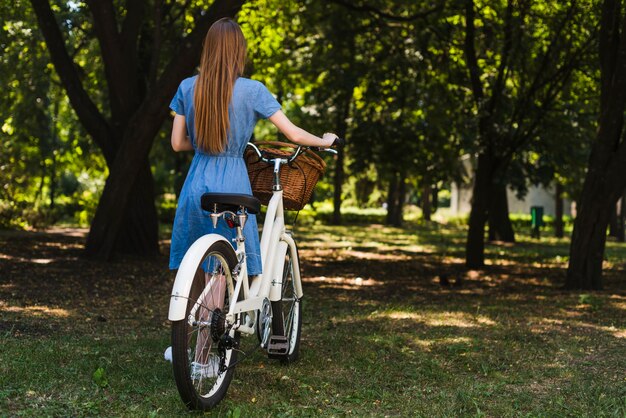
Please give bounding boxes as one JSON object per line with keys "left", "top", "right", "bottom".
{"left": 465, "top": 153, "right": 494, "bottom": 269}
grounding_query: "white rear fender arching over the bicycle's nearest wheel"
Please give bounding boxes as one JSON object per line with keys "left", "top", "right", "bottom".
{"left": 167, "top": 234, "right": 235, "bottom": 321}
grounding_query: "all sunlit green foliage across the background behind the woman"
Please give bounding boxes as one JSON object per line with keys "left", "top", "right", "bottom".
{"left": 0, "top": 0, "right": 599, "bottom": 232}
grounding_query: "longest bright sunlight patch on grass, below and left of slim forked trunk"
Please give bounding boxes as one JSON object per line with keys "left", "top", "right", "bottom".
{"left": 372, "top": 311, "right": 496, "bottom": 328}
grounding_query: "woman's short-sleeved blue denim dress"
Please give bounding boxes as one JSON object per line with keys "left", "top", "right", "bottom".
{"left": 170, "top": 76, "right": 280, "bottom": 275}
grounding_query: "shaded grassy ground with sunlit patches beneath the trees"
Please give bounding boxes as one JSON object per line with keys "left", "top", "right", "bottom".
{"left": 0, "top": 224, "right": 626, "bottom": 417}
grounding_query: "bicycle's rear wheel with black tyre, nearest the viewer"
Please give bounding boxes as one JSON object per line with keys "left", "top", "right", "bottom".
{"left": 172, "top": 242, "right": 239, "bottom": 410}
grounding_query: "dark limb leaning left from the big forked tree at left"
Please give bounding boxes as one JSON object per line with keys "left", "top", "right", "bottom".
{"left": 31, "top": 0, "right": 115, "bottom": 164}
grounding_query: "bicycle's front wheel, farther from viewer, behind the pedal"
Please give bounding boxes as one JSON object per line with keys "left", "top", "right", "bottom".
{"left": 272, "top": 243, "right": 302, "bottom": 364}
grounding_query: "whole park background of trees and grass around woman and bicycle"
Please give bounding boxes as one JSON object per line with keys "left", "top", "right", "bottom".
{"left": 0, "top": 0, "right": 626, "bottom": 416}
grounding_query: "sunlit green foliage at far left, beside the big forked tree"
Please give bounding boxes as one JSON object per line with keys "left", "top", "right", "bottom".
{"left": 0, "top": 2, "right": 107, "bottom": 228}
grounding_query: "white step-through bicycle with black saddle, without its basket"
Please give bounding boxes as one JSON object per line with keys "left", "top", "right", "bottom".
{"left": 168, "top": 144, "right": 336, "bottom": 410}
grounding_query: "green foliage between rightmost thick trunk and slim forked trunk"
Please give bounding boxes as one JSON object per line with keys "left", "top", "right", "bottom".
{"left": 455, "top": 1, "right": 599, "bottom": 199}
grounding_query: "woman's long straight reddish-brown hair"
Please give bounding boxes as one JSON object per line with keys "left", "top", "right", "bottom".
{"left": 193, "top": 18, "right": 246, "bottom": 154}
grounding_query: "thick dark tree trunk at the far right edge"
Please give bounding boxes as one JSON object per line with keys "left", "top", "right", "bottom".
{"left": 565, "top": 0, "right": 626, "bottom": 289}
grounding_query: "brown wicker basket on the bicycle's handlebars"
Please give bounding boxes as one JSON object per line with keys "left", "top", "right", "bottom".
{"left": 244, "top": 141, "right": 326, "bottom": 210}
